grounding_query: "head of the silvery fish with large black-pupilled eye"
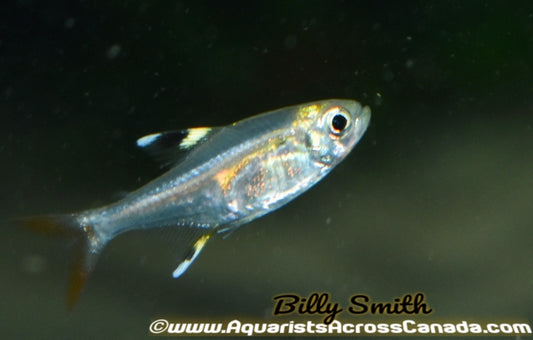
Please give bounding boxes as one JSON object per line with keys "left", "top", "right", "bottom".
{"left": 302, "top": 99, "right": 370, "bottom": 169}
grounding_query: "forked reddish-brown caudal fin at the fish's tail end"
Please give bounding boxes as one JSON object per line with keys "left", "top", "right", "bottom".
{"left": 18, "top": 214, "right": 103, "bottom": 310}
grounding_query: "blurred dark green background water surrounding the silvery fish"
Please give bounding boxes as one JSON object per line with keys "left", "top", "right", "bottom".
{"left": 0, "top": 0, "right": 533, "bottom": 339}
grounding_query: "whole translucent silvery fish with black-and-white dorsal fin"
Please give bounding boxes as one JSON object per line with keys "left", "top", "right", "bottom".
{"left": 22, "top": 99, "right": 371, "bottom": 309}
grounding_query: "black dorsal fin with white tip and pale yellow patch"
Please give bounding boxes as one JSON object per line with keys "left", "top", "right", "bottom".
{"left": 137, "top": 127, "right": 220, "bottom": 167}
